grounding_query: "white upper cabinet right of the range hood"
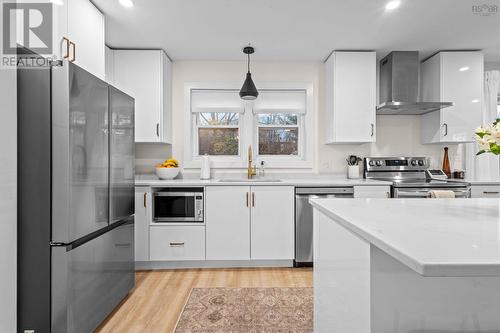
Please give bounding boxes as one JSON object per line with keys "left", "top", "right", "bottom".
{"left": 421, "top": 51, "right": 484, "bottom": 143}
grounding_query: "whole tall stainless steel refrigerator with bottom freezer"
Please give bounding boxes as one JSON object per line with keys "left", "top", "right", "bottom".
{"left": 18, "top": 49, "right": 134, "bottom": 333}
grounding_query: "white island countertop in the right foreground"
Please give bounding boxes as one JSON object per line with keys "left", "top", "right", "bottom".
{"left": 311, "top": 199, "right": 500, "bottom": 276}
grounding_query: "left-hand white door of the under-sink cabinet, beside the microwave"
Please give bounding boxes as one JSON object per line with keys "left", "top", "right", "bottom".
{"left": 205, "top": 186, "right": 250, "bottom": 260}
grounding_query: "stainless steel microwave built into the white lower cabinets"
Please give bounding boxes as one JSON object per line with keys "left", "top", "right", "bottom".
{"left": 153, "top": 192, "right": 203, "bottom": 223}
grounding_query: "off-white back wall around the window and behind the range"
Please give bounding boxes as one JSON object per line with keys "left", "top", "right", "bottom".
{"left": 136, "top": 61, "right": 463, "bottom": 173}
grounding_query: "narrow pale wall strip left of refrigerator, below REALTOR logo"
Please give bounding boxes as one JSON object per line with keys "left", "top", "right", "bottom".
{"left": 0, "top": 68, "right": 17, "bottom": 332}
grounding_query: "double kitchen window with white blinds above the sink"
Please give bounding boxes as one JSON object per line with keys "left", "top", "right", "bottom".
{"left": 184, "top": 84, "right": 314, "bottom": 168}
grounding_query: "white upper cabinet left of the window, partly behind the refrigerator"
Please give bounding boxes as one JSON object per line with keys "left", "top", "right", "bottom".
{"left": 113, "top": 49, "right": 172, "bottom": 143}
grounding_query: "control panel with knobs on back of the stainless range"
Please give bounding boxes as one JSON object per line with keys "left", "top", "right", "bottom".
{"left": 364, "top": 157, "right": 429, "bottom": 171}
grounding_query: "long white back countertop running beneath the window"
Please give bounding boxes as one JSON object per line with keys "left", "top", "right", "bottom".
{"left": 135, "top": 175, "right": 392, "bottom": 186}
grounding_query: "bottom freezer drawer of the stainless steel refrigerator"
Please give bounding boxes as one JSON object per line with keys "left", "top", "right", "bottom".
{"left": 52, "top": 218, "right": 134, "bottom": 333}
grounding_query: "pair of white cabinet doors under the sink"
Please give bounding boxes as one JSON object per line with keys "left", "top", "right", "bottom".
{"left": 205, "top": 186, "right": 294, "bottom": 260}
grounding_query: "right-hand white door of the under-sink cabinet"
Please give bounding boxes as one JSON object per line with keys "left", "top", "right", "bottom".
{"left": 250, "top": 186, "right": 295, "bottom": 260}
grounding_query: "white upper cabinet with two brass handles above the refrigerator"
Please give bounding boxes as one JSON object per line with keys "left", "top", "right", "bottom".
{"left": 54, "top": 0, "right": 105, "bottom": 80}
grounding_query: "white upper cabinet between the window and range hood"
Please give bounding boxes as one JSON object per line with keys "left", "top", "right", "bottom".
{"left": 325, "top": 51, "right": 377, "bottom": 144}
